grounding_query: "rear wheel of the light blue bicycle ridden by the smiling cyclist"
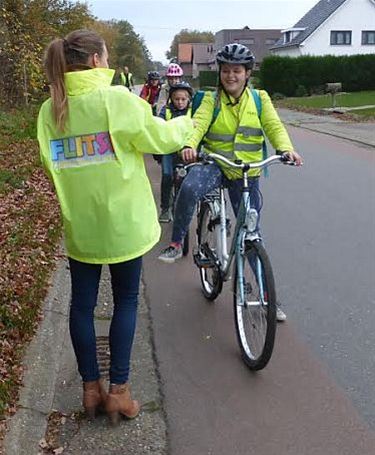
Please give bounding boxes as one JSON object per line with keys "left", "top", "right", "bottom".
{"left": 195, "top": 202, "right": 223, "bottom": 300}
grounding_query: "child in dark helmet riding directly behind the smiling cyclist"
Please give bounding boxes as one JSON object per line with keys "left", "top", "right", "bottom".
{"left": 159, "top": 82, "right": 193, "bottom": 223}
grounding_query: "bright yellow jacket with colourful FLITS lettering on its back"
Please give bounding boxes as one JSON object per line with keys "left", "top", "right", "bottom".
{"left": 38, "top": 68, "right": 193, "bottom": 264}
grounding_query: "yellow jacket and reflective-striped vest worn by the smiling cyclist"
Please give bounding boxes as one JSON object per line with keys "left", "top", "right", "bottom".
{"left": 185, "top": 88, "right": 293, "bottom": 179}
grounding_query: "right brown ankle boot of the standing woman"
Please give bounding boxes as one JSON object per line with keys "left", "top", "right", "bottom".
{"left": 105, "top": 383, "right": 140, "bottom": 425}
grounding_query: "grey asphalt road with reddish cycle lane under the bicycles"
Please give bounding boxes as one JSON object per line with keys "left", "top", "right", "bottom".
{"left": 144, "top": 128, "right": 375, "bottom": 455}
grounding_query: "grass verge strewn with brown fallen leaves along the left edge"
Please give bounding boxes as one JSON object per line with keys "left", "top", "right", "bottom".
{"left": 0, "top": 108, "right": 61, "bottom": 453}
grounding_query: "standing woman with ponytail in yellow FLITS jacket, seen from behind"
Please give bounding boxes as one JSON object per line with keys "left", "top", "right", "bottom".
{"left": 38, "top": 30, "right": 193, "bottom": 422}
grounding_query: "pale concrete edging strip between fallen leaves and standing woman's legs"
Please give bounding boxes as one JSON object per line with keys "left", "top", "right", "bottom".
{"left": 4, "top": 260, "right": 70, "bottom": 455}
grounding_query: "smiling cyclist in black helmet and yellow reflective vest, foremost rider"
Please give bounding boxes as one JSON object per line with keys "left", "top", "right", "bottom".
{"left": 159, "top": 43, "right": 302, "bottom": 319}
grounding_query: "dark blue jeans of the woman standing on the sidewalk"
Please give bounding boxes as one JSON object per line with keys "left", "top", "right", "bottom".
{"left": 69, "top": 257, "right": 142, "bottom": 384}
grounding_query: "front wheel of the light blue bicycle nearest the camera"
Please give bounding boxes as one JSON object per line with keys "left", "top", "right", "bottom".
{"left": 234, "top": 242, "right": 276, "bottom": 370}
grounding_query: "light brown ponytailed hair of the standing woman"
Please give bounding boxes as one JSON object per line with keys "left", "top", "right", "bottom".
{"left": 44, "top": 30, "right": 105, "bottom": 131}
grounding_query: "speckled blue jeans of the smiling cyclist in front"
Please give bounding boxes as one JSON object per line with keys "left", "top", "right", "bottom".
{"left": 172, "top": 163, "right": 261, "bottom": 243}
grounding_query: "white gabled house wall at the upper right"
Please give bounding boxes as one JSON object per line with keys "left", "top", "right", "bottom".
{"left": 302, "top": 0, "right": 375, "bottom": 57}
